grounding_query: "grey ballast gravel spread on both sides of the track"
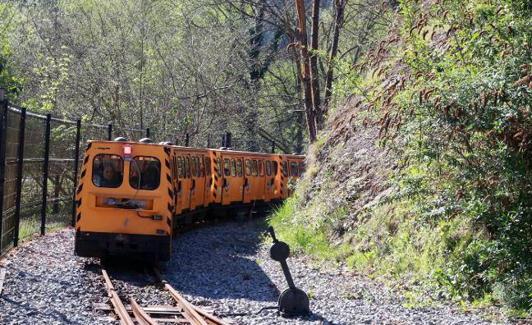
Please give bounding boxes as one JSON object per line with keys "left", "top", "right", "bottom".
{"left": 0, "top": 221, "right": 508, "bottom": 324}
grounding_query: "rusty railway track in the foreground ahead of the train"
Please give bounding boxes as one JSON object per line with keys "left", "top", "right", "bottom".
{"left": 102, "top": 269, "right": 228, "bottom": 325}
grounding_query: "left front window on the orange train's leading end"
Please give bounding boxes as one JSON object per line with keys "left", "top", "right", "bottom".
{"left": 92, "top": 154, "right": 124, "bottom": 188}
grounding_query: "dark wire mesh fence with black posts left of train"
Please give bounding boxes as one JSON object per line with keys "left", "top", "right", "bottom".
{"left": 0, "top": 94, "right": 149, "bottom": 255}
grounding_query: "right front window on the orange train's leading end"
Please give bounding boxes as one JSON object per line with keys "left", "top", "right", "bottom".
{"left": 129, "top": 157, "right": 161, "bottom": 190}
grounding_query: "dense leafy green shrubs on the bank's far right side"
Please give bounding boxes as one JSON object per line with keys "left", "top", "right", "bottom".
{"left": 392, "top": 1, "right": 532, "bottom": 309}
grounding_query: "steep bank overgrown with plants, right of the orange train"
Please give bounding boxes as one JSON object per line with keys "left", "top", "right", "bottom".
{"left": 271, "top": 0, "right": 532, "bottom": 314}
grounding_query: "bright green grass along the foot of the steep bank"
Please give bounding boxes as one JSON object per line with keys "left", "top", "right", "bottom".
{"left": 269, "top": 183, "right": 512, "bottom": 318}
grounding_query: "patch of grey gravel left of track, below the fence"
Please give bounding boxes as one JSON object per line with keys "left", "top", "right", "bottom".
{"left": 0, "top": 230, "right": 113, "bottom": 324}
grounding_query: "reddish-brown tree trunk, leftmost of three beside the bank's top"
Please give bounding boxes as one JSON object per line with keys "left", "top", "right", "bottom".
{"left": 295, "top": 0, "right": 316, "bottom": 143}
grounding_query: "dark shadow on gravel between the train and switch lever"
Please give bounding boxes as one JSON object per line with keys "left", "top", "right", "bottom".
{"left": 163, "top": 219, "right": 279, "bottom": 304}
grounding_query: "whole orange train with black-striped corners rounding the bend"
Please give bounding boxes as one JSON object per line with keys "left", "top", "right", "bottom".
{"left": 75, "top": 139, "right": 304, "bottom": 261}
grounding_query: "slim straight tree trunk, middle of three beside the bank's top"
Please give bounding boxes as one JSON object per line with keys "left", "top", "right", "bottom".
{"left": 310, "top": 0, "right": 323, "bottom": 130}
